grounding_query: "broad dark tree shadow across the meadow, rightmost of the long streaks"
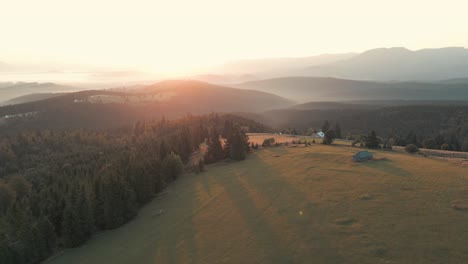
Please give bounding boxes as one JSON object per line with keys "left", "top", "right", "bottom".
{"left": 238, "top": 156, "right": 346, "bottom": 263}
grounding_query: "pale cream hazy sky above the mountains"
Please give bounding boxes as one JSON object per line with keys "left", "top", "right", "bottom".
{"left": 0, "top": 0, "right": 468, "bottom": 74}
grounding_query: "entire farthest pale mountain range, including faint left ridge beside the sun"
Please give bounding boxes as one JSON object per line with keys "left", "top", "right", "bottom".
{"left": 193, "top": 47, "right": 468, "bottom": 83}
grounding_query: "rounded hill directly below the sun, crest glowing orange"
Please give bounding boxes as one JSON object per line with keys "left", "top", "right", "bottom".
{"left": 0, "top": 81, "right": 292, "bottom": 131}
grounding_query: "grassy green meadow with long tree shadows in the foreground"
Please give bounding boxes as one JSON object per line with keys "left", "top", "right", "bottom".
{"left": 47, "top": 144, "right": 468, "bottom": 264}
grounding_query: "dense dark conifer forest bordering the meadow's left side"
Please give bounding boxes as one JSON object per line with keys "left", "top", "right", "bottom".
{"left": 0, "top": 114, "right": 254, "bottom": 264}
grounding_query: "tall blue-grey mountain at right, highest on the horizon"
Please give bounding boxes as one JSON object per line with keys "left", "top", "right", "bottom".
{"left": 300, "top": 48, "right": 468, "bottom": 81}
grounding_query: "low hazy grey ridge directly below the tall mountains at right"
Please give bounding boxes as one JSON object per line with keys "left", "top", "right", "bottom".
{"left": 234, "top": 77, "right": 468, "bottom": 102}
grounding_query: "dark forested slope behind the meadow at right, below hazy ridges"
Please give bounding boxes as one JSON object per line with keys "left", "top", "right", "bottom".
{"left": 243, "top": 102, "right": 468, "bottom": 151}
